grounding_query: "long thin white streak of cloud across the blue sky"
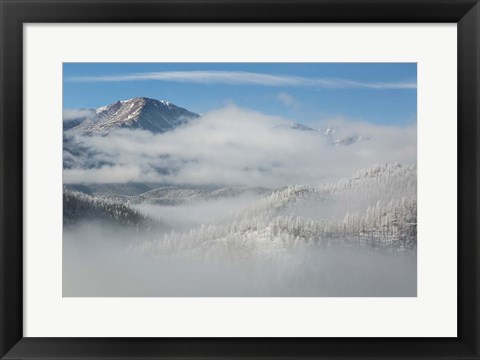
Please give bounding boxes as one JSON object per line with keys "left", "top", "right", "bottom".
{"left": 66, "top": 71, "right": 417, "bottom": 90}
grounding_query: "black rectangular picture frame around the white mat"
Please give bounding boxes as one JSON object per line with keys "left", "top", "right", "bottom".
{"left": 0, "top": 0, "right": 480, "bottom": 359}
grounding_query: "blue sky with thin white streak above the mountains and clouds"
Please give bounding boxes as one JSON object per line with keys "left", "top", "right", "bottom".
{"left": 63, "top": 63, "right": 417, "bottom": 126}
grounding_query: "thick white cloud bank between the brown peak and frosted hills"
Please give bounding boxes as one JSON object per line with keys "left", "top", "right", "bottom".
{"left": 64, "top": 106, "right": 417, "bottom": 187}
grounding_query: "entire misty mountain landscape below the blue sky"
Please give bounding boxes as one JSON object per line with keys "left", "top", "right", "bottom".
{"left": 63, "top": 98, "right": 417, "bottom": 297}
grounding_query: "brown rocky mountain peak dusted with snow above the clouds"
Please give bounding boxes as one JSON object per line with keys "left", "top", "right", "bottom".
{"left": 70, "top": 97, "right": 200, "bottom": 135}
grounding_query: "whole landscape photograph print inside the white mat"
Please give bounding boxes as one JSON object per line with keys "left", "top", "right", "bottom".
{"left": 62, "top": 63, "right": 417, "bottom": 297}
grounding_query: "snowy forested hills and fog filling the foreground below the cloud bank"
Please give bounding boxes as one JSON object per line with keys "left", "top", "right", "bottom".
{"left": 63, "top": 164, "right": 416, "bottom": 296}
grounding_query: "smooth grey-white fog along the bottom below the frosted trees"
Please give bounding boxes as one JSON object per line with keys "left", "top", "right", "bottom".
{"left": 63, "top": 218, "right": 416, "bottom": 297}
